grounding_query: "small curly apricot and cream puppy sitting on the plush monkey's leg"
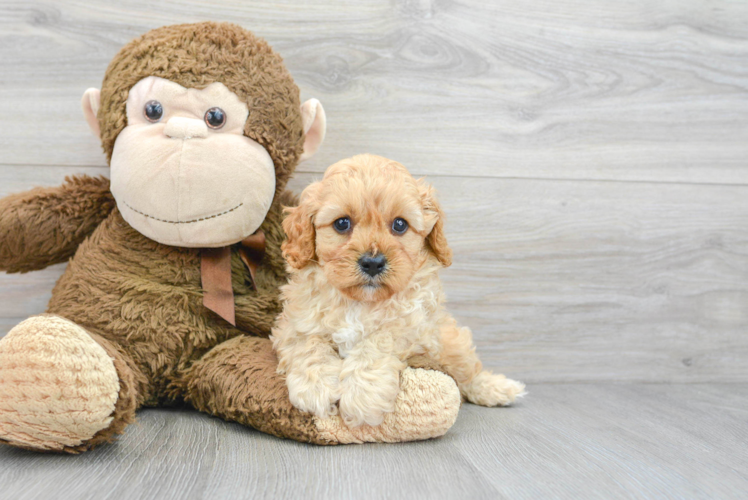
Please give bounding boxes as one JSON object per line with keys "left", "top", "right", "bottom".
{"left": 271, "top": 155, "right": 524, "bottom": 427}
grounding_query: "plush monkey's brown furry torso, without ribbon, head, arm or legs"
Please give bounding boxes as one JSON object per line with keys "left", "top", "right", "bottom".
{"left": 42, "top": 188, "right": 289, "bottom": 406}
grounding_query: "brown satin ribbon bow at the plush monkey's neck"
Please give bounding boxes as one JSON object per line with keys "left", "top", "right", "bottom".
{"left": 200, "top": 230, "right": 265, "bottom": 326}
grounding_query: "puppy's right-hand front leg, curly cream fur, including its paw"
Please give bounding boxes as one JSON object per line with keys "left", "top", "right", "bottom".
{"left": 339, "top": 342, "right": 405, "bottom": 427}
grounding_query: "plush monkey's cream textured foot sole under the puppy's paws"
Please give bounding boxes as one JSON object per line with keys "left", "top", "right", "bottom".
{"left": 315, "top": 368, "right": 461, "bottom": 444}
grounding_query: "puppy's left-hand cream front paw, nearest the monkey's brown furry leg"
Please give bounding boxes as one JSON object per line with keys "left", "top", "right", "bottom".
{"left": 286, "top": 372, "right": 340, "bottom": 418}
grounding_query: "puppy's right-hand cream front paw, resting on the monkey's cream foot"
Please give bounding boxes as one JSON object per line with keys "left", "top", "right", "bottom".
{"left": 339, "top": 369, "right": 400, "bottom": 427}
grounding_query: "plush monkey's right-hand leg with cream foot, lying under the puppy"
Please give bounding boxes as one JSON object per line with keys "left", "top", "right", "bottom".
{"left": 184, "top": 337, "right": 460, "bottom": 444}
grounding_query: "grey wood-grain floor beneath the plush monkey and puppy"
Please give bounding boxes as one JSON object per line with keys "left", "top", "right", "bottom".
{"left": 0, "top": 384, "right": 748, "bottom": 500}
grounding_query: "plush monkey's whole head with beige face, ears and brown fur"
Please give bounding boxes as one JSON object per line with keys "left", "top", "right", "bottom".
{"left": 82, "top": 23, "right": 325, "bottom": 248}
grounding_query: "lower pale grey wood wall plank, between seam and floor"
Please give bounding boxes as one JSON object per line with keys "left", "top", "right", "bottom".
{"left": 0, "top": 167, "right": 748, "bottom": 383}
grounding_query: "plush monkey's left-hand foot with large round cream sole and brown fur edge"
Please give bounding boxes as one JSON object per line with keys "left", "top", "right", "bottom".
{"left": 0, "top": 315, "right": 143, "bottom": 453}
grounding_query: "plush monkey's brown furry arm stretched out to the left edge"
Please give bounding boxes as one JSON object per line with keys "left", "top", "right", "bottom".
{"left": 0, "top": 175, "right": 115, "bottom": 273}
